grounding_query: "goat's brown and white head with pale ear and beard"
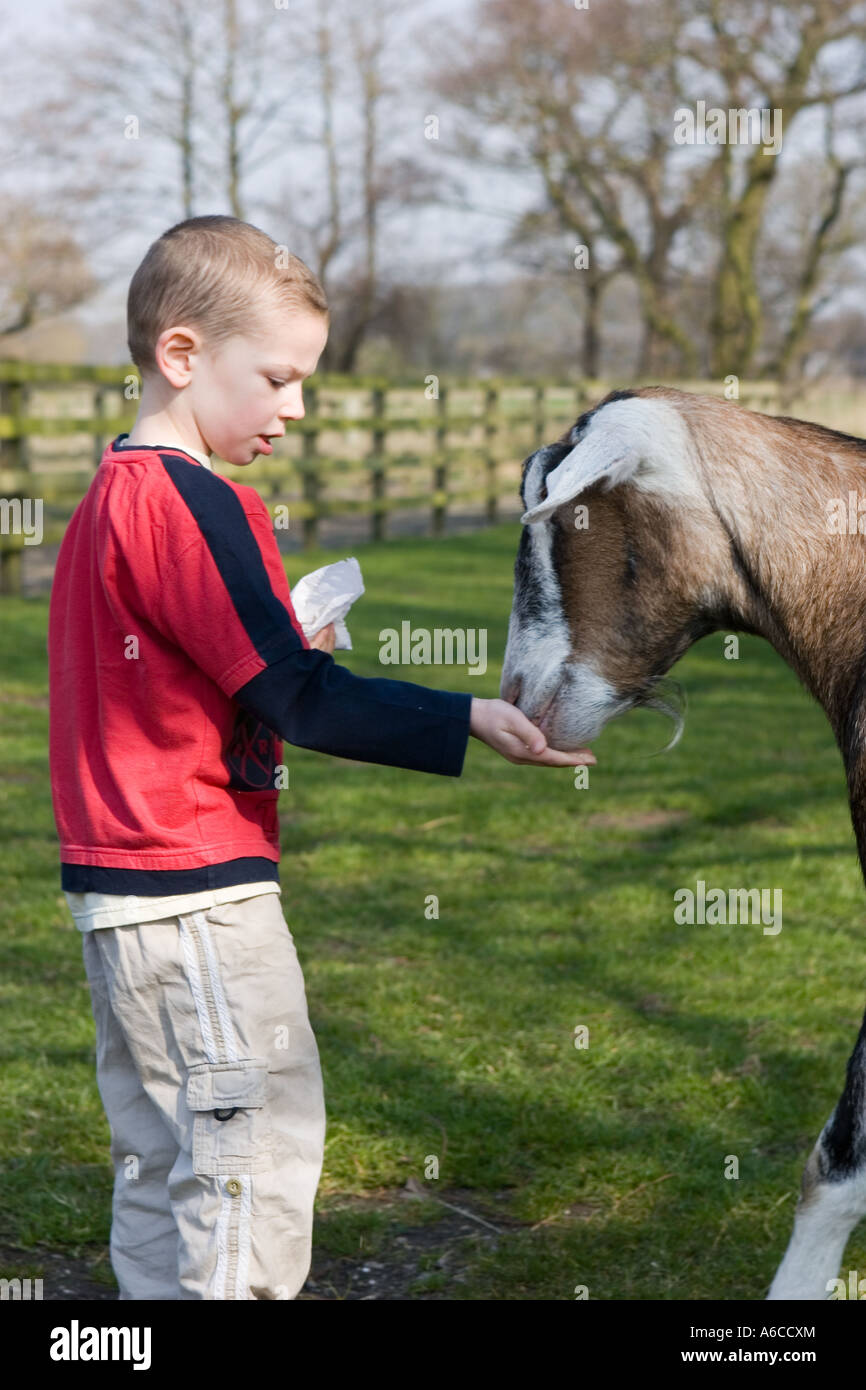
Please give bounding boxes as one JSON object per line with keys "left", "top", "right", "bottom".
{"left": 500, "top": 392, "right": 730, "bottom": 749}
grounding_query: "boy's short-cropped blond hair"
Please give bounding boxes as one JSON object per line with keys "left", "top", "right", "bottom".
{"left": 126, "top": 214, "right": 328, "bottom": 374}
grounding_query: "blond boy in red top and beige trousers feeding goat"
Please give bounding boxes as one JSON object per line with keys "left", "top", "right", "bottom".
{"left": 49, "top": 217, "right": 594, "bottom": 1300}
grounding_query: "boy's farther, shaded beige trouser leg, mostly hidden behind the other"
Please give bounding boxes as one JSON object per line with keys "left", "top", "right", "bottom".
{"left": 82, "top": 931, "right": 181, "bottom": 1300}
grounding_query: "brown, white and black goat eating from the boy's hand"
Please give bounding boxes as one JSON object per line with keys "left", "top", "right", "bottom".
{"left": 500, "top": 386, "right": 866, "bottom": 1300}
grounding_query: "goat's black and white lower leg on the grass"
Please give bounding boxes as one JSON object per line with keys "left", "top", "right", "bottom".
{"left": 767, "top": 1017, "right": 866, "bottom": 1300}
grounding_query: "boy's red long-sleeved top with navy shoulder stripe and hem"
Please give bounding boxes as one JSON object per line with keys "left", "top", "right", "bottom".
{"left": 47, "top": 436, "right": 471, "bottom": 895}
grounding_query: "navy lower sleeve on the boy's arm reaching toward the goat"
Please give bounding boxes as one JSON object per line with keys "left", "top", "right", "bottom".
{"left": 234, "top": 644, "right": 473, "bottom": 777}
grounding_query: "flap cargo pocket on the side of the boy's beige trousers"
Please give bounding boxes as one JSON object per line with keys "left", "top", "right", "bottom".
{"left": 186, "top": 1056, "right": 274, "bottom": 1177}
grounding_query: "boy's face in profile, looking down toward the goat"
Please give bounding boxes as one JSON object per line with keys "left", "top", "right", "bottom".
{"left": 176, "top": 307, "right": 328, "bottom": 464}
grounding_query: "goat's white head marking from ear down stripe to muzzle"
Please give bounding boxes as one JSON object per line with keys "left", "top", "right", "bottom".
{"left": 500, "top": 398, "right": 706, "bottom": 749}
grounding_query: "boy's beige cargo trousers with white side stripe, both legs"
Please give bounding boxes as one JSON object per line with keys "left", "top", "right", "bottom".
{"left": 82, "top": 892, "right": 325, "bottom": 1300}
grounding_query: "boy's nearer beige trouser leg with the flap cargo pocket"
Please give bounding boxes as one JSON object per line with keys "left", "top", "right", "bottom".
{"left": 90, "top": 894, "right": 325, "bottom": 1298}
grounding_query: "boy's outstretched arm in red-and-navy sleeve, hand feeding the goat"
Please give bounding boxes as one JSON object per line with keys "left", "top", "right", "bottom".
{"left": 132, "top": 453, "right": 594, "bottom": 777}
